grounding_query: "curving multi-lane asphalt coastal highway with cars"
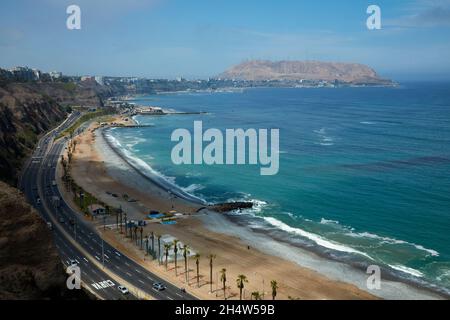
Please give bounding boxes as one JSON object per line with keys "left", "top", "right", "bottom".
{"left": 21, "top": 112, "right": 195, "bottom": 300}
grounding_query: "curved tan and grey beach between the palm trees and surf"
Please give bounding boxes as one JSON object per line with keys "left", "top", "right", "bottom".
{"left": 62, "top": 115, "right": 438, "bottom": 299}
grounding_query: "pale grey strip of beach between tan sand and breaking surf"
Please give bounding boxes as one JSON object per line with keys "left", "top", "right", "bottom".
{"left": 71, "top": 115, "right": 442, "bottom": 299}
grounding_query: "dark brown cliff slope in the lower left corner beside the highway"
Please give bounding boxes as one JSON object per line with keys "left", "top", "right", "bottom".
{"left": 0, "top": 182, "right": 87, "bottom": 300}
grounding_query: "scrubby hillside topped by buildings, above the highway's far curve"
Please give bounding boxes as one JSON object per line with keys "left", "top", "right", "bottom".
{"left": 0, "top": 81, "right": 109, "bottom": 185}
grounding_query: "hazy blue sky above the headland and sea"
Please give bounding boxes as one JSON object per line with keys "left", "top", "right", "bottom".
{"left": 0, "top": 0, "right": 450, "bottom": 80}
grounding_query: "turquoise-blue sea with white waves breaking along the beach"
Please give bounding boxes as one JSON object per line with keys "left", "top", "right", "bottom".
{"left": 109, "top": 83, "right": 450, "bottom": 292}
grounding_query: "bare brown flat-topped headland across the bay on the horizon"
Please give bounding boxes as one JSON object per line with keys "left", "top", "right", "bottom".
{"left": 219, "top": 60, "right": 387, "bottom": 84}
